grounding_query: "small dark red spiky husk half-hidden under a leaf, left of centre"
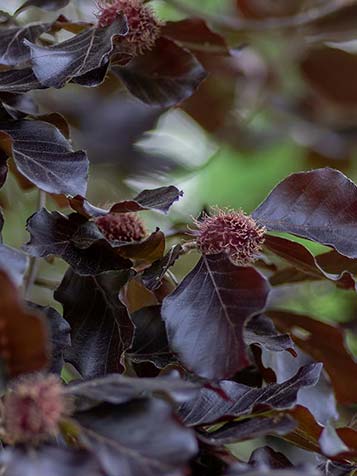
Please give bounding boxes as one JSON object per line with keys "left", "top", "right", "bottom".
{"left": 95, "top": 213, "right": 146, "bottom": 242}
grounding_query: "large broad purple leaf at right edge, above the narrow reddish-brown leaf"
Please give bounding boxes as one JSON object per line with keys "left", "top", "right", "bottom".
{"left": 253, "top": 168, "right": 357, "bottom": 258}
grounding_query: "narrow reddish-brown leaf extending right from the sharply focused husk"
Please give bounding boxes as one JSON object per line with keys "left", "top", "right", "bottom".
{"left": 264, "top": 235, "right": 356, "bottom": 289}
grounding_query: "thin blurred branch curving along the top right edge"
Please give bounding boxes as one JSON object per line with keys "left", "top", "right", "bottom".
{"left": 165, "top": 0, "right": 357, "bottom": 31}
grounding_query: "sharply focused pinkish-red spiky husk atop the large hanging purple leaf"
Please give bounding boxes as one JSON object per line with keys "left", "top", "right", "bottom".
{"left": 195, "top": 209, "right": 266, "bottom": 266}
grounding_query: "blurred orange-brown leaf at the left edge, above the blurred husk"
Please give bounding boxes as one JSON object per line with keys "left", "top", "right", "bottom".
{"left": 0, "top": 271, "right": 49, "bottom": 377}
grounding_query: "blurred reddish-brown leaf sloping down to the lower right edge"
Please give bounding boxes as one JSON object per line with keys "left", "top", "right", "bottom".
{"left": 267, "top": 310, "right": 357, "bottom": 404}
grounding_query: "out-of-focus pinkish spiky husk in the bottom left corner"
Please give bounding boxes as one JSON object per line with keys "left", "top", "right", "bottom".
{"left": 2, "top": 374, "right": 69, "bottom": 444}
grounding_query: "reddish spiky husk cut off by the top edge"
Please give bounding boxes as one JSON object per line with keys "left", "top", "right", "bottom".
{"left": 97, "top": 0, "right": 162, "bottom": 56}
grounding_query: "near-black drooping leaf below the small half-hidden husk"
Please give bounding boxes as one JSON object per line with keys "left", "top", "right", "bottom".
{"left": 55, "top": 270, "right": 134, "bottom": 377}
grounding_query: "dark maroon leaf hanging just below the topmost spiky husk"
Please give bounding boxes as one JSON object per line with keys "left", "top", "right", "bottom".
{"left": 112, "top": 37, "right": 206, "bottom": 107}
